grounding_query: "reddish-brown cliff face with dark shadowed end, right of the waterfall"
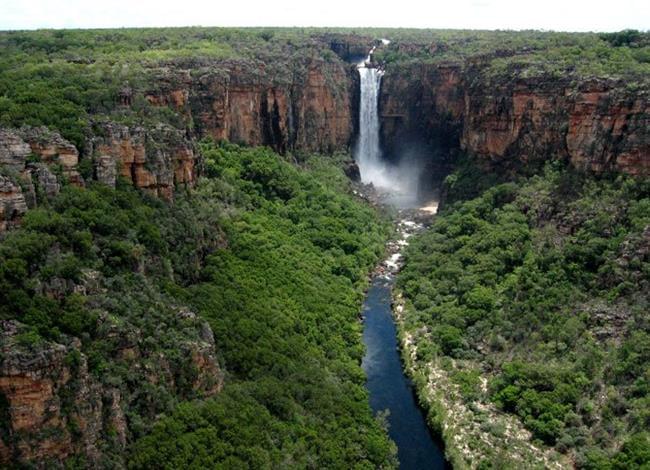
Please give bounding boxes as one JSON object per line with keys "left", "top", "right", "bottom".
{"left": 381, "top": 64, "right": 650, "bottom": 175}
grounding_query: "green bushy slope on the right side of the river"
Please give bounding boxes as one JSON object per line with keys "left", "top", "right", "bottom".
{"left": 398, "top": 164, "right": 650, "bottom": 469}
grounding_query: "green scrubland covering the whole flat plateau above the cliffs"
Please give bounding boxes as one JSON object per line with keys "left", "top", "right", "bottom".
{"left": 0, "top": 28, "right": 650, "bottom": 149}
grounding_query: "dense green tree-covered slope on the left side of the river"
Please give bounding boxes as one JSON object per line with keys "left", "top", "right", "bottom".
{"left": 0, "top": 143, "right": 394, "bottom": 468}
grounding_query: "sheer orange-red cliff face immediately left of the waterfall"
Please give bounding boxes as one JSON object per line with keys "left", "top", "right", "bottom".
{"left": 146, "top": 58, "right": 356, "bottom": 153}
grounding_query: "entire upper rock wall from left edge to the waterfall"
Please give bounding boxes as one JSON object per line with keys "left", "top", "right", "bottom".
{"left": 0, "top": 56, "right": 361, "bottom": 231}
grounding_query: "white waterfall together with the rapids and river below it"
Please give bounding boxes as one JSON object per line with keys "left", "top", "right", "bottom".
{"left": 354, "top": 43, "right": 447, "bottom": 470}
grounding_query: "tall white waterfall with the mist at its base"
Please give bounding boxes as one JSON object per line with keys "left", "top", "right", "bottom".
{"left": 355, "top": 61, "right": 426, "bottom": 207}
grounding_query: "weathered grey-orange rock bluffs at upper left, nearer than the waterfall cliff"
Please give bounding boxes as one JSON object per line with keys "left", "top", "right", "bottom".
{"left": 0, "top": 125, "right": 199, "bottom": 232}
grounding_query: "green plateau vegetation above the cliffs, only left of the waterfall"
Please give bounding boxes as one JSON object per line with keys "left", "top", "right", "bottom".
{"left": 0, "top": 28, "right": 341, "bottom": 149}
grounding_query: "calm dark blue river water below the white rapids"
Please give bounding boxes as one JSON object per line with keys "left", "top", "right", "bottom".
{"left": 362, "top": 278, "right": 451, "bottom": 470}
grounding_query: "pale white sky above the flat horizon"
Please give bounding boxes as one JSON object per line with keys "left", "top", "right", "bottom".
{"left": 0, "top": 0, "right": 650, "bottom": 31}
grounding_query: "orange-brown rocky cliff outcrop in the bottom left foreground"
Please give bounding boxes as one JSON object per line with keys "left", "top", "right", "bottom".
{"left": 0, "top": 314, "right": 223, "bottom": 468}
